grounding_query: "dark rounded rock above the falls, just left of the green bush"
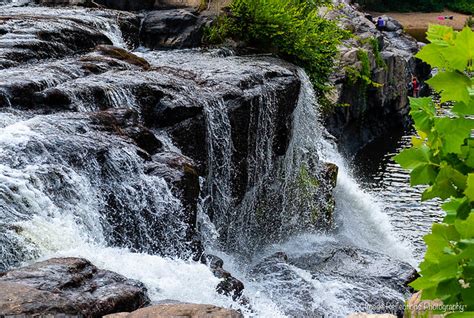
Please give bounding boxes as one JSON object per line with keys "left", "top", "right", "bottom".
{"left": 140, "top": 9, "right": 212, "bottom": 49}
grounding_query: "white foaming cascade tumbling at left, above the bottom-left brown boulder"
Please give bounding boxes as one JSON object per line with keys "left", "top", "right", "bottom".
{"left": 0, "top": 113, "right": 193, "bottom": 267}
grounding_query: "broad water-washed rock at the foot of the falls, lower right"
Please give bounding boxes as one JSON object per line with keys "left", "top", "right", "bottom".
{"left": 249, "top": 246, "right": 415, "bottom": 317}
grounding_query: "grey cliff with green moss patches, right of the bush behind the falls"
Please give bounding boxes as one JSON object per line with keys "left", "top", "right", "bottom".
{"left": 326, "top": 1, "right": 429, "bottom": 154}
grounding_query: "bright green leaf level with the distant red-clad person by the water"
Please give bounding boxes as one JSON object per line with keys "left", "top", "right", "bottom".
{"left": 426, "top": 72, "right": 471, "bottom": 104}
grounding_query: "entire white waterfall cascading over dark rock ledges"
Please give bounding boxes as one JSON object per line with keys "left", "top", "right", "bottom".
{"left": 0, "top": 1, "right": 422, "bottom": 317}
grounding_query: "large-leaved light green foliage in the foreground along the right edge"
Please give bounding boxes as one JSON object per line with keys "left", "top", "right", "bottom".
{"left": 395, "top": 25, "right": 474, "bottom": 317}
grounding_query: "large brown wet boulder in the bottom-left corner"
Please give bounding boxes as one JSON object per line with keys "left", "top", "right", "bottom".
{"left": 0, "top": 258, "right": 149, "bottom": 317}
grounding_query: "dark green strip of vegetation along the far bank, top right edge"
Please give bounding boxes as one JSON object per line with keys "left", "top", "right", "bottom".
{"left": 357, "top": 0, "right": 474, "bottom": 14}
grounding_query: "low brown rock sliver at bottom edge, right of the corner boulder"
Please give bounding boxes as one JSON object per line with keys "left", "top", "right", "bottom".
{"left": 105, "top": 304, "right": 244, "bottom": 318}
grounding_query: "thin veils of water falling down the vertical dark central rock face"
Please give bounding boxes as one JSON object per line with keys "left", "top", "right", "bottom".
{"left": 202, "top": 70, "right": 333, "bottom": 254}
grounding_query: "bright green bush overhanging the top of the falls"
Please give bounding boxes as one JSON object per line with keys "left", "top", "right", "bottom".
{"left": 207, "top": 0, "right": 349, "bottom": 95}
